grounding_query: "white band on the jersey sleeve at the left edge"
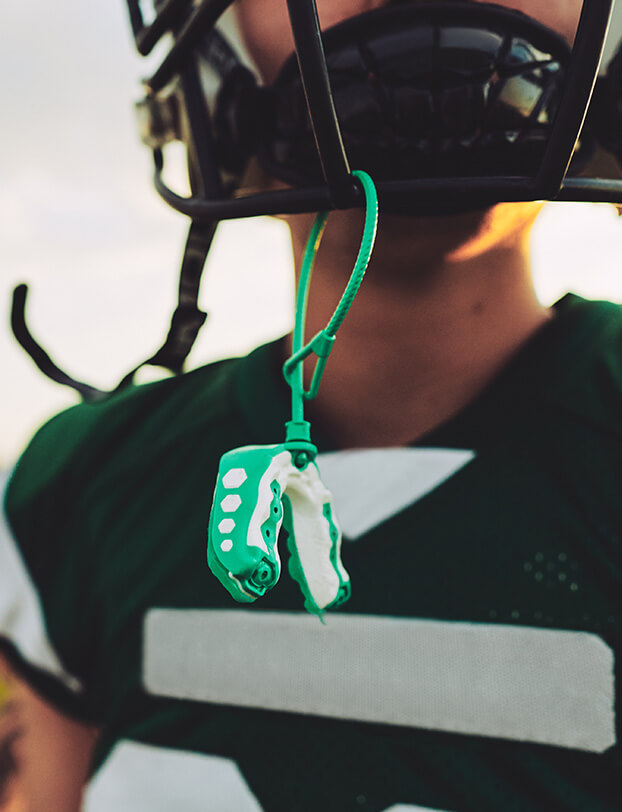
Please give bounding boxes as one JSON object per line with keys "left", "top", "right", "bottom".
{"left": 0, "top": 471, "right": 82, "bottom": 691}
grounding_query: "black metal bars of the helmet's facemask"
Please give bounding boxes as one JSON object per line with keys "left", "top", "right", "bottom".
{"left": 128, "top": 0, "right": 622, "bottom": 221}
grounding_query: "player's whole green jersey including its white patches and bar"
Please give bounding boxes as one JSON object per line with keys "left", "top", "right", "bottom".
{"left": 0, "top": 296, "right": 622, "bottom": 812}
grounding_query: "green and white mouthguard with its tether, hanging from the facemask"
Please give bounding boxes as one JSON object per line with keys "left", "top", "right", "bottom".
{"left": 207, "top": 172, "right": 378, "bottom": 617}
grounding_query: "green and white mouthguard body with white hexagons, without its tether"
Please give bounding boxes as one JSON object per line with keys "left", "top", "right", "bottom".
{"left": 207, "top": 444, "right": 350, "bottom": 614}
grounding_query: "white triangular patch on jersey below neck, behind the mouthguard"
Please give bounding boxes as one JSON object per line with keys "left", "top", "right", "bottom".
{"left": 317, "top": 448, "right": 475, "bottom": 539}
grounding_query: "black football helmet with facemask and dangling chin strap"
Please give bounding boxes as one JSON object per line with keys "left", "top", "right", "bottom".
{"left": 13, "top": 0, "right": 622, "bottom": 398}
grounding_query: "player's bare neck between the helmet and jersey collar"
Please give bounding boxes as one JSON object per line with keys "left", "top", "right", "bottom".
{"left": 290, "top": 219, "right": 550, "bottom": 447}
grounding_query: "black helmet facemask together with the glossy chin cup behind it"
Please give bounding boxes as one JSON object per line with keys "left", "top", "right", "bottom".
{"left": 129, "top": 0, "right": 622, "bottom": 220}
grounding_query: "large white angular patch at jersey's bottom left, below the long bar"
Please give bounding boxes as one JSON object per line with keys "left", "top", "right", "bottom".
{"left": 82, "top": 740, "right": 261, "bottom": 812}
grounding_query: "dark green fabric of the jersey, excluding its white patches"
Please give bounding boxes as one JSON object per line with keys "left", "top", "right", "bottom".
{"left": 7, "top": 296, "right": 622, "bottom": 812}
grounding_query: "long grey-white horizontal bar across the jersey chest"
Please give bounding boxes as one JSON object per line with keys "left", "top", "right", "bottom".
{"left": 143, "top": 609, "right": 615, "bottom": 752}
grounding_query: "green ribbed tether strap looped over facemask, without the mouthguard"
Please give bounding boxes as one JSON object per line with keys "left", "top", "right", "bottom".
{"left": 283, "top": 170, "right": 378, "bottom": 432}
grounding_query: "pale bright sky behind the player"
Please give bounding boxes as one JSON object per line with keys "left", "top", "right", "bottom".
{"left": 0, "top": 0, "right": 622, "bottom": 466}
